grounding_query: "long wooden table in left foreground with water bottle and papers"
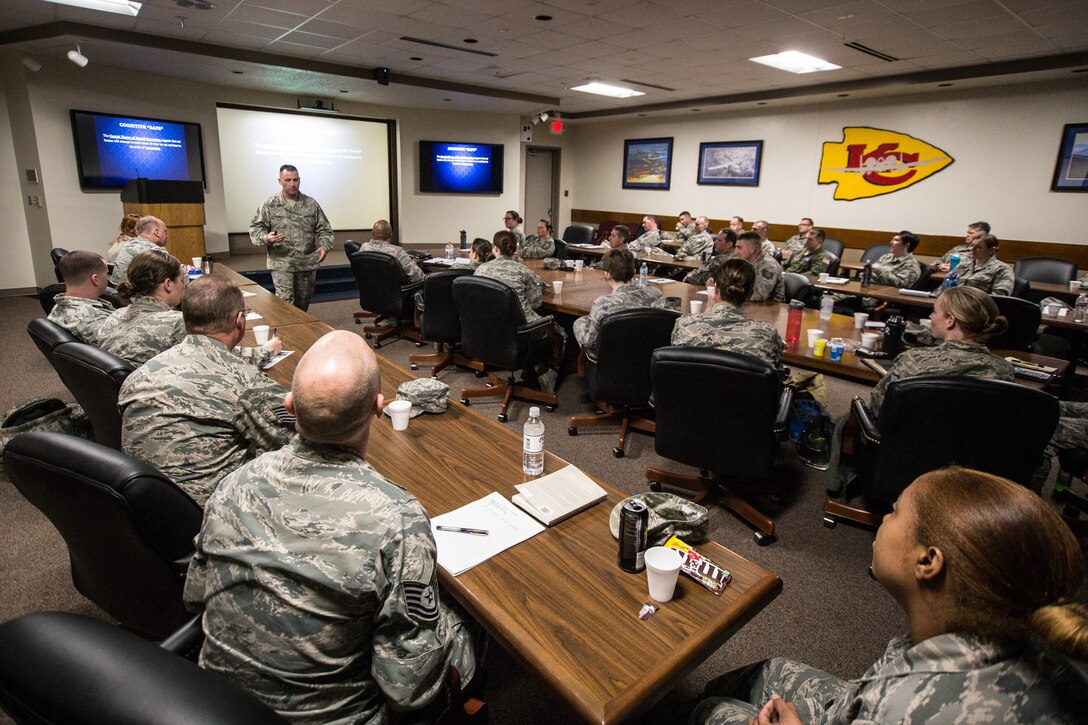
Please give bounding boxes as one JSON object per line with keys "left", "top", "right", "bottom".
{"left": 215, "top": 265, "right": 782, "bottom": 723}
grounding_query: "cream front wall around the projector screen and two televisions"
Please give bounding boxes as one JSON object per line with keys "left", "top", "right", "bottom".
{"left": 0, "top": 61, "right": 526, "bottom": 290}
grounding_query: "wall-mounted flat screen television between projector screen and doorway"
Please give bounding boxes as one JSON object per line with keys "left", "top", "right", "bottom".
{"left": 419, "top": 140, "right": 503, "bottom": 194}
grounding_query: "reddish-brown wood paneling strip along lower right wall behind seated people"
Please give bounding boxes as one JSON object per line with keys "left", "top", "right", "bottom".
{"left": 570, "top": 209, "right": 1088, "bottom": 270}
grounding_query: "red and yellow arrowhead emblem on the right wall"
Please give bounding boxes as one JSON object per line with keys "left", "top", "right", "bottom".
{"left": 818, "top": 126, "right": 953, "bottom": 201}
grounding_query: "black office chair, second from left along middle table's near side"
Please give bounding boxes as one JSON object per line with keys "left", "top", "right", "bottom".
{"left": 408, "top": 269, "right": 484, "bottom": 378}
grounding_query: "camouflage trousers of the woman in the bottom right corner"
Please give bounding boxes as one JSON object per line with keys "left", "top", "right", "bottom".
{"left": 689, "top": 658, "right": 856, "bottom": 725}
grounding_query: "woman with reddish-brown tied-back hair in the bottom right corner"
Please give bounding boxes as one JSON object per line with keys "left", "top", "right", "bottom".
{"left": 691, "top": 467, "right": 1088, "bottom": 725}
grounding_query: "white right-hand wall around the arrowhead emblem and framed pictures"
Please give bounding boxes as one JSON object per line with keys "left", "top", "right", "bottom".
{"left": 571, "top": 76, "right": 1088, "bottom": 244}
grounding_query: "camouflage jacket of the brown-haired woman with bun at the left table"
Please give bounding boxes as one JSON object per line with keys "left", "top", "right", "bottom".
{"left": 98, "top": 295, "right": 273, "bottom": 367}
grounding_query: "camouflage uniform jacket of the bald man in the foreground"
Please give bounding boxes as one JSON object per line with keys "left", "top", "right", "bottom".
{"left": 185, "top": 438, "right": 475, "bottom": 723}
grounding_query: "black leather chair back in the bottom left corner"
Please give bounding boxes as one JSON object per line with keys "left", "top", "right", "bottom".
{"left": 0, "top": 612, "right": 287, "bottom": 725}
